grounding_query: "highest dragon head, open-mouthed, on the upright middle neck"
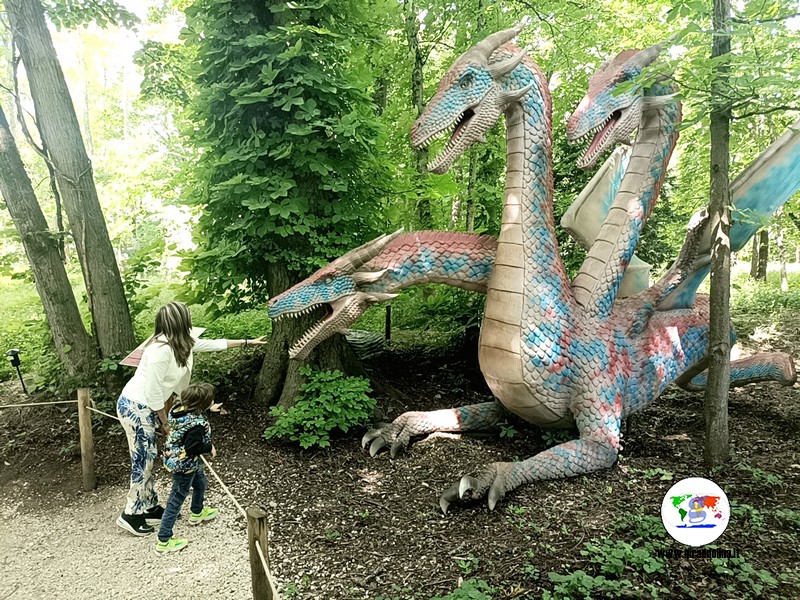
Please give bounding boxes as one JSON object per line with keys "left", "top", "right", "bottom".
{"left": 411, "top": 24, "right": 531, "bottom": 173}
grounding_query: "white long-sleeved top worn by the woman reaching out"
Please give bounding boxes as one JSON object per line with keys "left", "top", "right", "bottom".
{"left": 122, "top": 336, "right": 228, "bottom": 411}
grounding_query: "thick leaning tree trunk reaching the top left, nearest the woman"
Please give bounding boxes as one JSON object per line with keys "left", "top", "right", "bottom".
{"left": 6, "top": 0, "right": 136, "bottom": 356}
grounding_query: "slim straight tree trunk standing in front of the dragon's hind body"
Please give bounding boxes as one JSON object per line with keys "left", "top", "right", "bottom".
{"left": 704, "top": 0, "right": 731, "bottom": 467}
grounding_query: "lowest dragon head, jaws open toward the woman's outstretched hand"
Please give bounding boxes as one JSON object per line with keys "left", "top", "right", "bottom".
{"left": 269, "top": 230, "right": 402, "bottom": 359}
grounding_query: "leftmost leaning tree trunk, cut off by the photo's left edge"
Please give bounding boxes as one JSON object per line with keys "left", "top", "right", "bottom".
{"left": 0, "top": 107, "right": 96, "bottom": 382}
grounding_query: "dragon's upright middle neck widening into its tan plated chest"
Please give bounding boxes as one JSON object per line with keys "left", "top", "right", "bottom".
{"left": 478, "top": 59, "right": 574, "bottom": 425}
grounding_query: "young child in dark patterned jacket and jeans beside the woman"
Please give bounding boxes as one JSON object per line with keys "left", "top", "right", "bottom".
{"left": 156, "top": 383, "right": 219, "bottom": 554}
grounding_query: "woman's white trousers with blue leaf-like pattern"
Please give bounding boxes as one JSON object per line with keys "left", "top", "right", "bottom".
{"left": 117, "top": 396, "right": 158, "bottom": 515}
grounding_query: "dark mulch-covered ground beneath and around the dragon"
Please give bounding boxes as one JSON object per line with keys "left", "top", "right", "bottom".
{"left": 0, "top": 323, "right": 800, "bottom": 600}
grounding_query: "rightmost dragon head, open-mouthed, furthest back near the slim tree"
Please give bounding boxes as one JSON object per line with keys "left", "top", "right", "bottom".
{"left": 567, "top": 43, "right": 664, "bottom": 169}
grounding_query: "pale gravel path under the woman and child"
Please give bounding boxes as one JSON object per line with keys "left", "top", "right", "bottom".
{"left": 0, "top": 486, "right": 252, "bottom": 600}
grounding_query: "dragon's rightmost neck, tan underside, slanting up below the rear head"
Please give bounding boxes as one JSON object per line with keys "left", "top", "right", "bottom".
{"left": 572, "top": 87, "right": 681, "bottom": 319}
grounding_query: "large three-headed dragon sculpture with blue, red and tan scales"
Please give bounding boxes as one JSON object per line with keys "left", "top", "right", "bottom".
{"left": 269, "top": 28, "right": 800, "bottom": 512}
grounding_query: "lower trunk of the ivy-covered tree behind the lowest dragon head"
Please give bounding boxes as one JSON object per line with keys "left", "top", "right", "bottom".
{"left": 254, "top": 265, "right": 364, "bottom": 408}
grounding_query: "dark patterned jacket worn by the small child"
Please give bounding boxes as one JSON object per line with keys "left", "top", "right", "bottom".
{"left": 164, "top": 406, "right": 211, "bottom": 473}
